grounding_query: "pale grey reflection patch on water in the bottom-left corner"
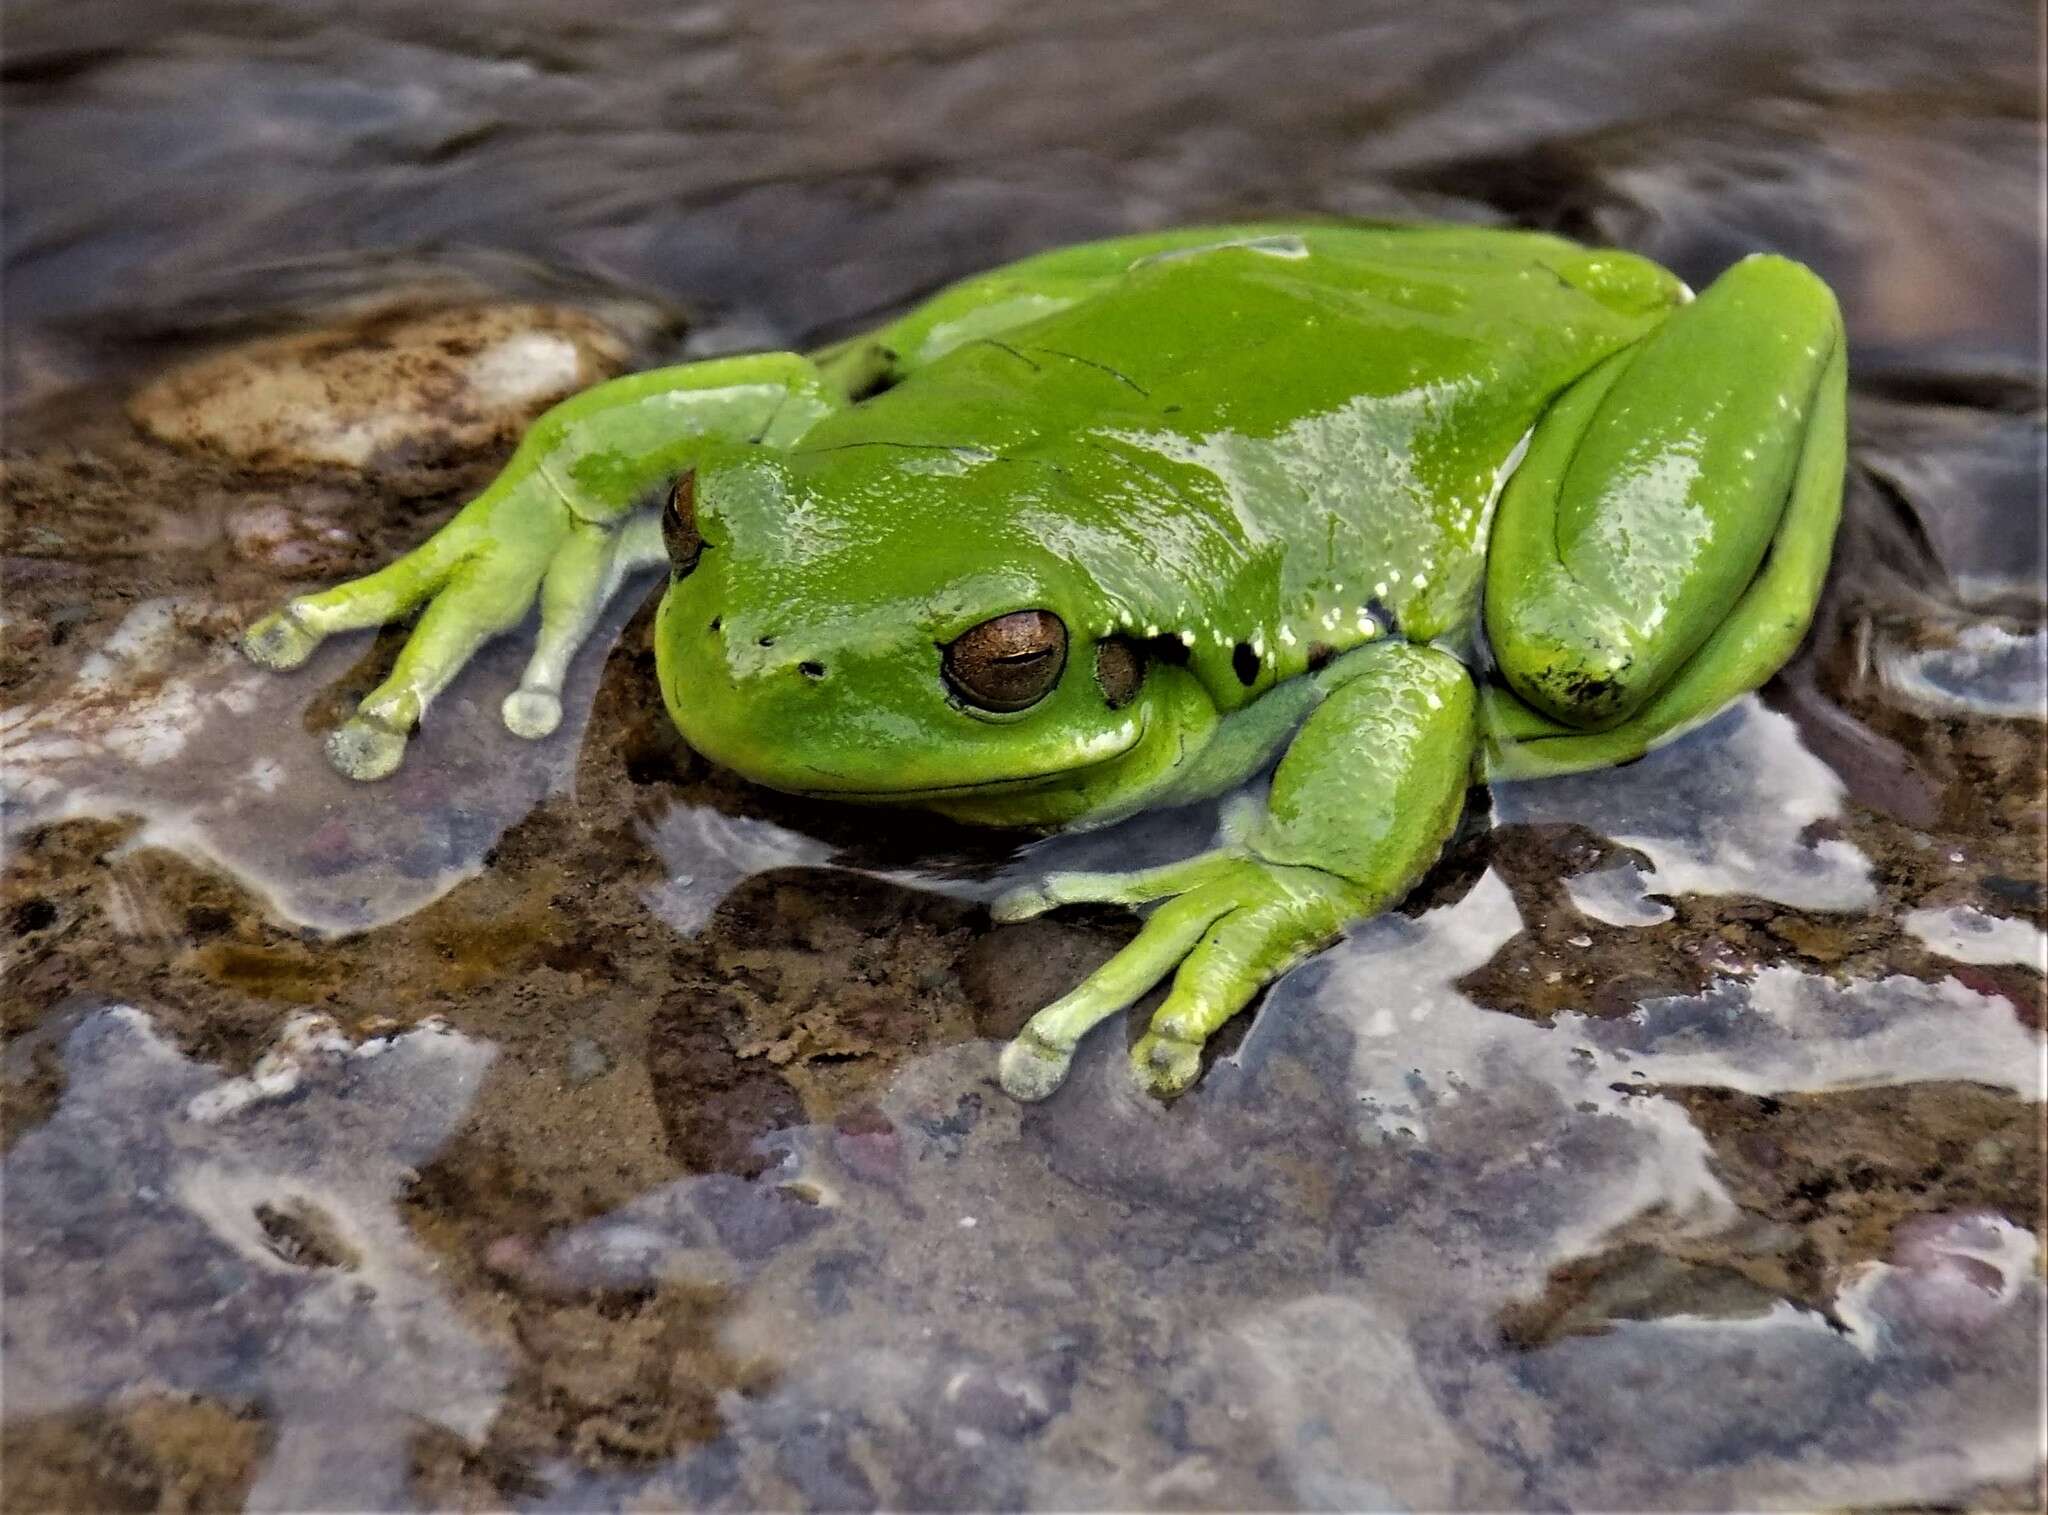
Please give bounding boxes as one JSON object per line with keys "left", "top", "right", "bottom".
{"left": 4, "top": 1007, "right": 506, "bottom": 1509}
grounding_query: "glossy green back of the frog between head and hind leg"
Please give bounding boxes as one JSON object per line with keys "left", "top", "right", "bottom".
{"left": 798, "top": 225, "right": 1681, "bottom": 694}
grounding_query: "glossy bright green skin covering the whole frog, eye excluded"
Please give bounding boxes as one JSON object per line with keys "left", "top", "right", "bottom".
{"left": 244, "top": 223, "right": 1845, "bottom": 1099}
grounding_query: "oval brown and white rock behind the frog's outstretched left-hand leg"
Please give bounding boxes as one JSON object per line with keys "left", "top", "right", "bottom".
{"left": 129, "top": 303, "right": 633, "bottom": 491}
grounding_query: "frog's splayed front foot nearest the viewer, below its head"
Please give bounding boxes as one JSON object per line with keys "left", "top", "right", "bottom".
{"left": 997, "top": 852, "right": 1364, "bottom": 1099}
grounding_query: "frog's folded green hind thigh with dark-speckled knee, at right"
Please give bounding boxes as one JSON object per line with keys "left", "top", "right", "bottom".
{"left": 1487, "top": 256, "right": 1843, "bottom": 729}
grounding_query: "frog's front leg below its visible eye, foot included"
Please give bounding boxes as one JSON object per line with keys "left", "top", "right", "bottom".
{"left": 997, "top": 643, "right": 1477, "bottom": 1099}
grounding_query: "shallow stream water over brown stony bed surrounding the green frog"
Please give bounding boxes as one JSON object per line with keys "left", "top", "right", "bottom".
{"left": 0, "top": 0, "right": 2048, "bottom": 1509}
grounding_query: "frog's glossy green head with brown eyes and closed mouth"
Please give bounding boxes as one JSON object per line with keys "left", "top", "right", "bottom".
{"left": 655, "top": 446, "right": 1217, "bottom": 825}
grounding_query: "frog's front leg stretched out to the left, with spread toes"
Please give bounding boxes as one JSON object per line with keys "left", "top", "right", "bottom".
{"left": 242, "top": 352, "right": 844, "bottom": 780}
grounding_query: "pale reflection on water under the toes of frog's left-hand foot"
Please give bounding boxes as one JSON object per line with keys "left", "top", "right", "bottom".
{"left": 0, "top": 594, "right": 637, "bottom": 932}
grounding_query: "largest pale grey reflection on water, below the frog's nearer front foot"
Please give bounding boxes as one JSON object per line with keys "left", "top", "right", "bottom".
{"left": 499, "top": 874, "right": 2044, "bottom": 1509}
